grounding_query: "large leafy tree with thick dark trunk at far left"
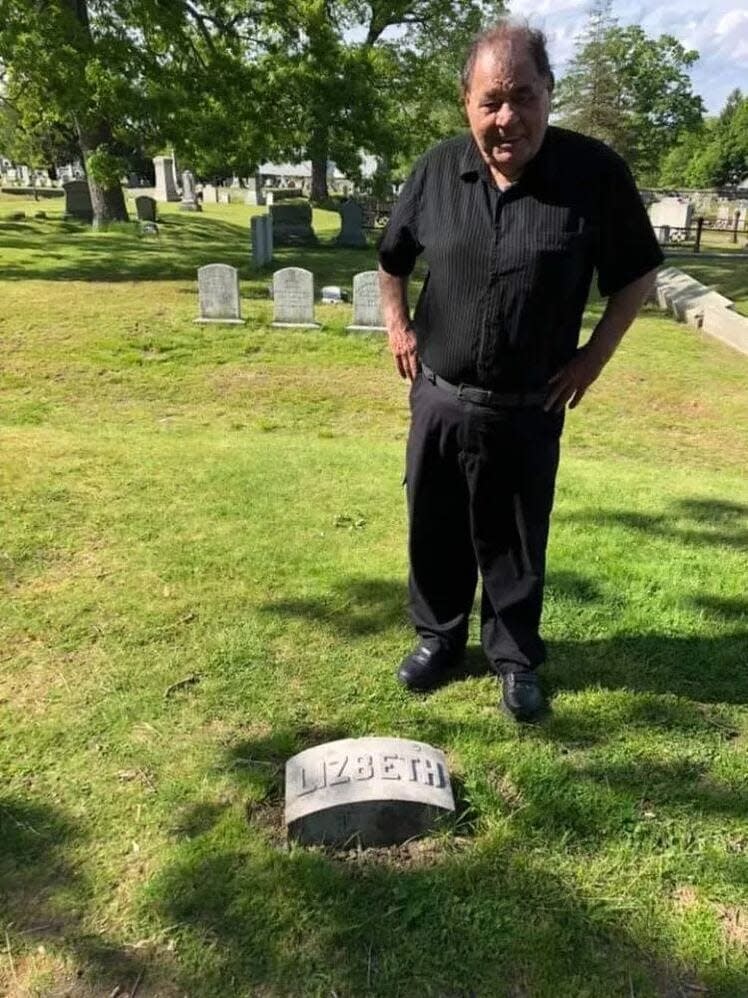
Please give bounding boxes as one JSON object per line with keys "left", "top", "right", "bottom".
{"left": 0, "top": 0, "right": 272, "bottom": 225}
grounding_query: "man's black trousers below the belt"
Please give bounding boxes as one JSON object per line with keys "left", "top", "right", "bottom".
{"left": 406, "top": 374, "right": 564, "bottom": 672}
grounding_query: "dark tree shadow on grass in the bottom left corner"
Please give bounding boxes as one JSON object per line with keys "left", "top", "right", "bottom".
{"left": 0, "top": 796, "right": 145, "bottom": 998}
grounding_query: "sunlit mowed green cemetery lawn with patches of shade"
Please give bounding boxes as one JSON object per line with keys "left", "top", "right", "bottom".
{"left": 0, "top": 200, "right": 748, "bottom": 998}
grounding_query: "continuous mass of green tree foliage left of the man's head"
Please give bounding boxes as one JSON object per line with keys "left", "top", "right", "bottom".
{"left": 0, "top": 0, "right": 503, "bottom": 218}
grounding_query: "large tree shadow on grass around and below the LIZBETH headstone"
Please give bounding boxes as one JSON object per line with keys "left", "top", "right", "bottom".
{"left": 139, "top": 711, "right": 748, "bottom": 998}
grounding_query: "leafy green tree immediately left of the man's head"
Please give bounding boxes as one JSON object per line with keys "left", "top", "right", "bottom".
{"left": 248, "top": 0, "right": 503, "bottom": 199}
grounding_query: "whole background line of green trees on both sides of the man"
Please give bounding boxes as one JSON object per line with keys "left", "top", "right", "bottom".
{"left": 0, "top": 0, "right": 748, "bottom": 223}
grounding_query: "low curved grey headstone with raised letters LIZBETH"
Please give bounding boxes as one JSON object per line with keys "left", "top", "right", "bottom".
{"left": 286, "top": 738, "right": 455, "bottom": 847}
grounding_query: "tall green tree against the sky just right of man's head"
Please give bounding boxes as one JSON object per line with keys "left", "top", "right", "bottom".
{"left": 556, "top": 2, "right": 704, "bottom": 183}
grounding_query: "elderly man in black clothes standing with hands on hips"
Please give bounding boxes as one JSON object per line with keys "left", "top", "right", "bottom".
{"left": 379, "top": 20, "right": 662, "bottom": 720}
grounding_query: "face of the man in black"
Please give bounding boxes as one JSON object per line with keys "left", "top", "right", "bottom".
{"left": 465, "top": 38, "right": 551, "bottom": 181}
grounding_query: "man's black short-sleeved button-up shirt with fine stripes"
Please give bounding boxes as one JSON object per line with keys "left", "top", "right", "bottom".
{"left": 379, "top": 126, "right": 663, "bottom": 390}
